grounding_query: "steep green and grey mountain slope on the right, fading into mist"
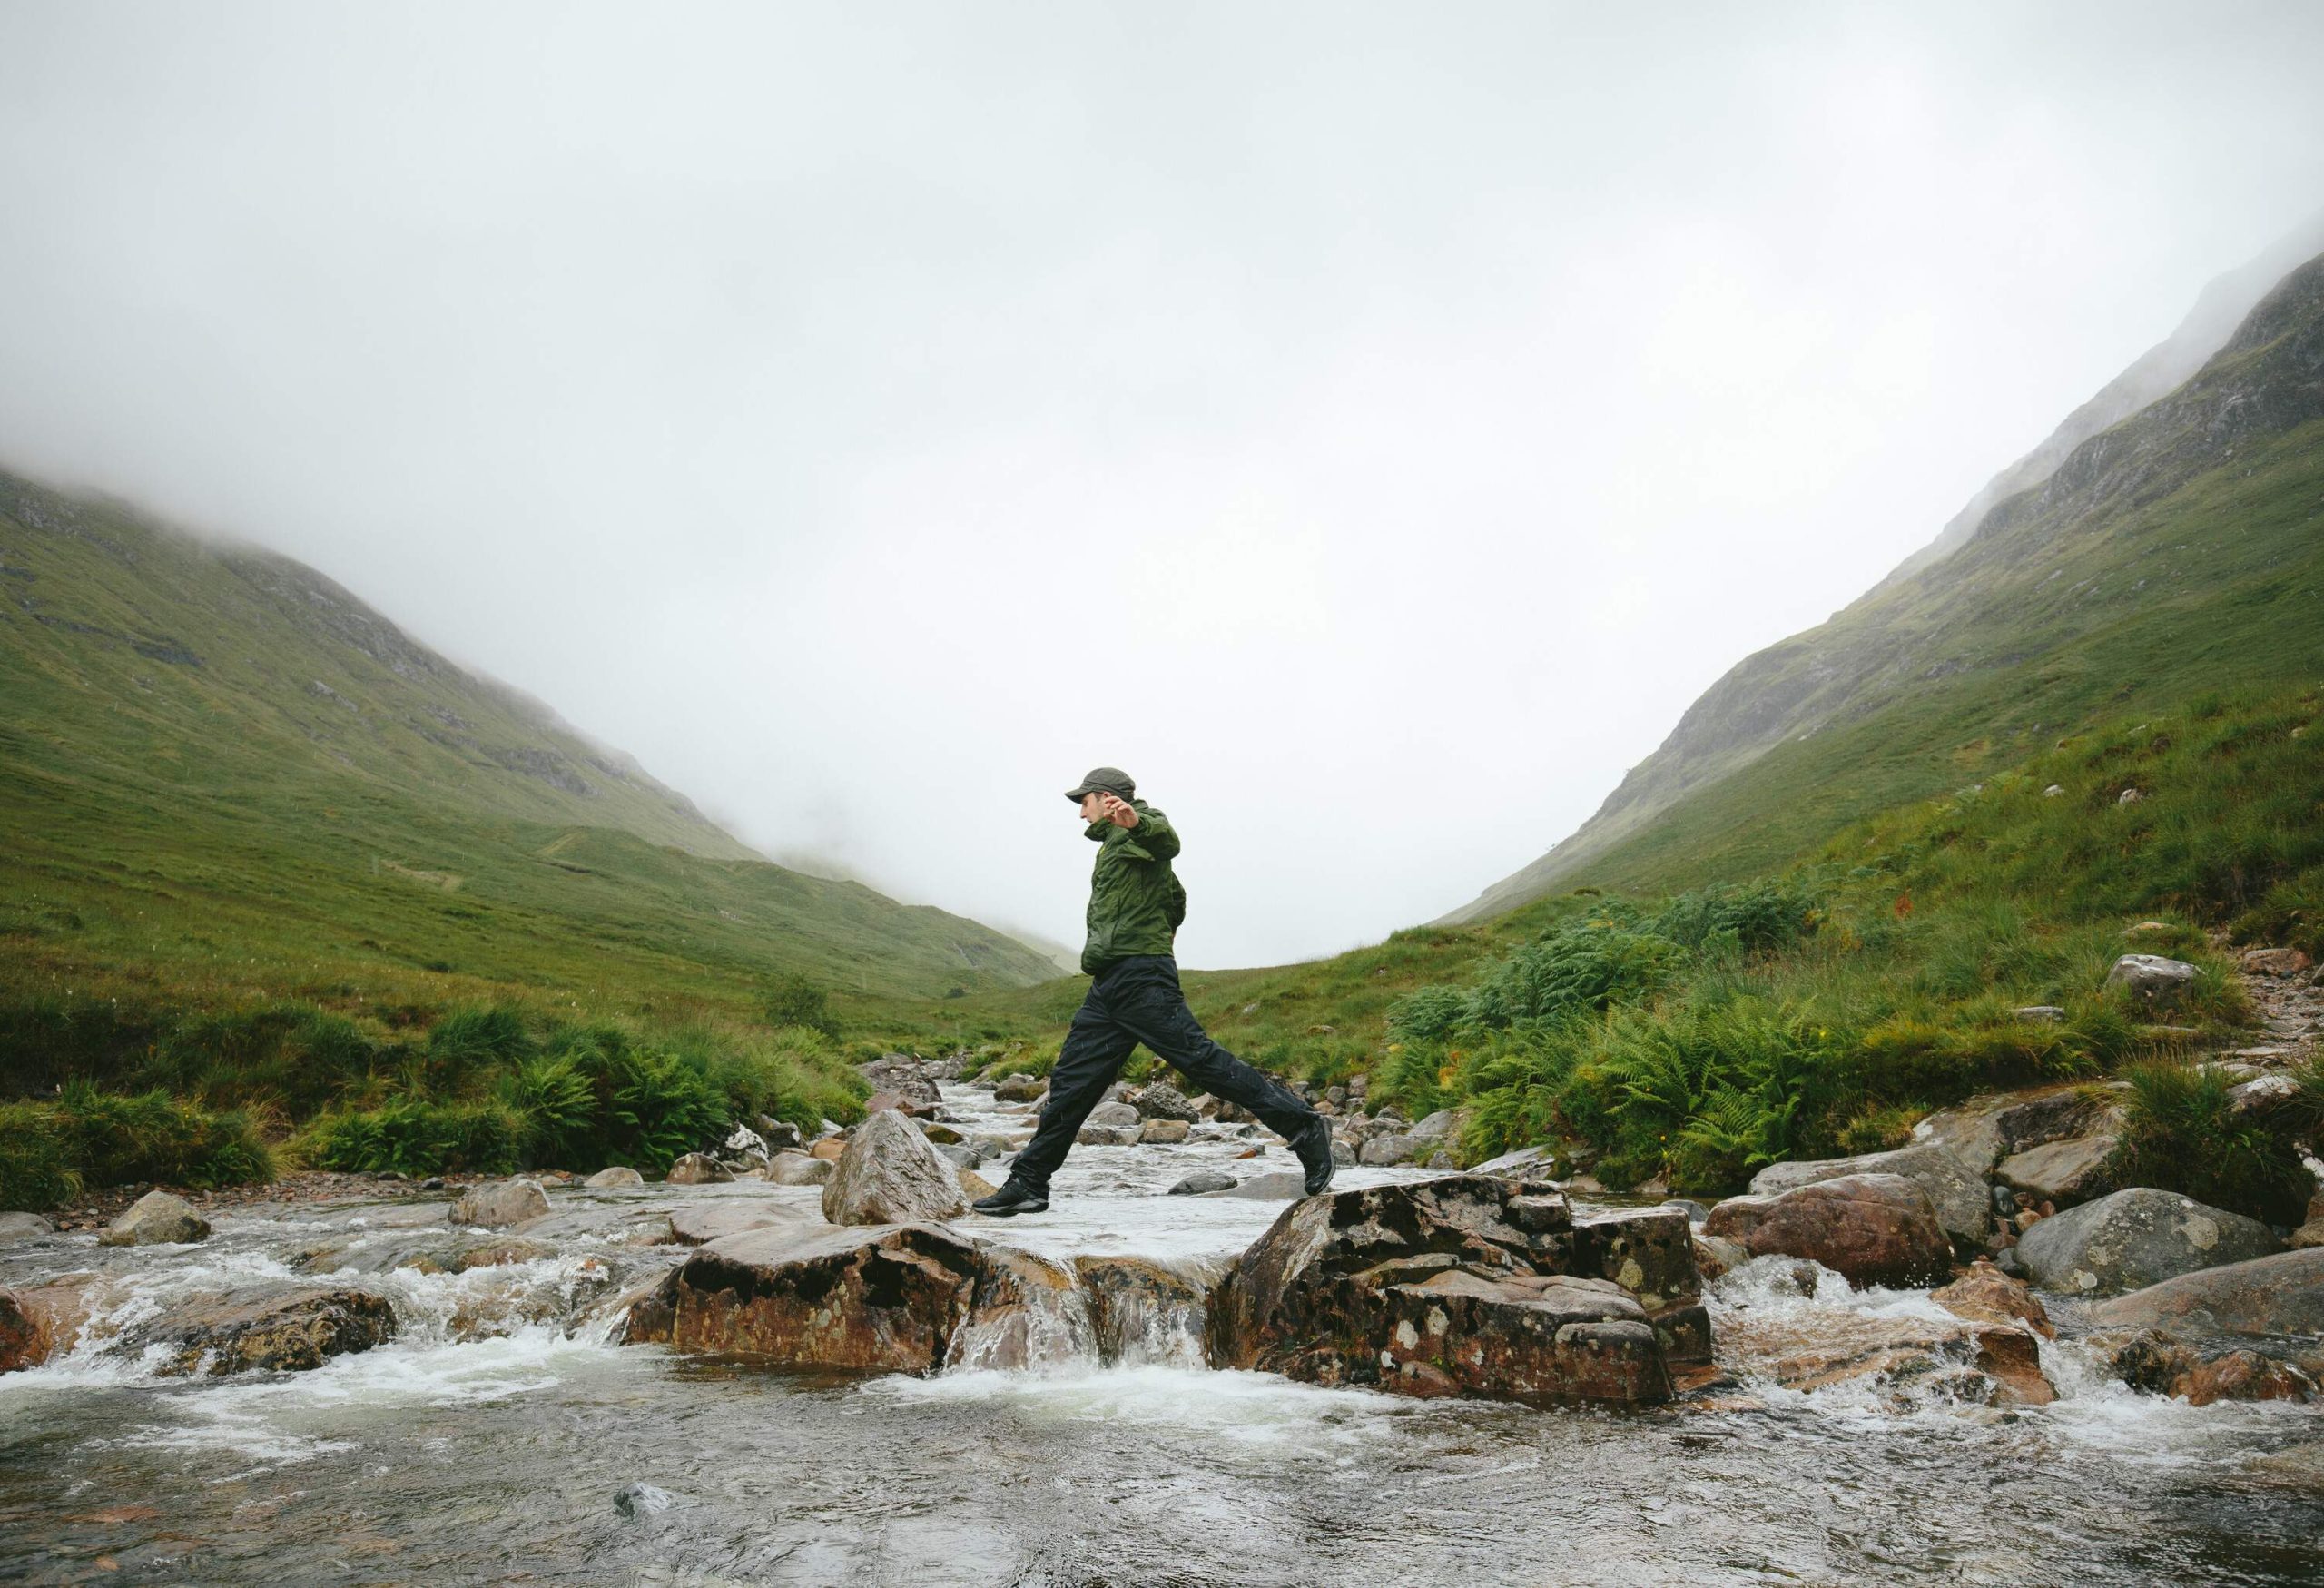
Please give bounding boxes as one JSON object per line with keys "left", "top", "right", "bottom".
{"left": 1445, "top": 246, "right": 2324, "bottom": 923}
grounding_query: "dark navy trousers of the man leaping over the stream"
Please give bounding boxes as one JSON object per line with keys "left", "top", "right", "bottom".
{"left": 1009, "top": 953, "right": 1315, "bottom": 1193}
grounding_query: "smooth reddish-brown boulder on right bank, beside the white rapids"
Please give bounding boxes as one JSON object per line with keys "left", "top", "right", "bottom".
{"left": 1703, "top": 1174, "right": 1952, "bottom": 1286}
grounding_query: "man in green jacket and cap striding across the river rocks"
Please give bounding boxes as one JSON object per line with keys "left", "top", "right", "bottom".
{"left": 974, "top": 767, "right": 1332, "bottom": 1216}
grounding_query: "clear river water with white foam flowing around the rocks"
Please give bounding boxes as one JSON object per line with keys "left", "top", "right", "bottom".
{"left": 0, "top": 1088, "right": 2324, "bottom": 1588}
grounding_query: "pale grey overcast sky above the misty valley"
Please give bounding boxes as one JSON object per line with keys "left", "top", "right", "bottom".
{"left": 0, "top": 0, "right": 2324, "bottom": 967}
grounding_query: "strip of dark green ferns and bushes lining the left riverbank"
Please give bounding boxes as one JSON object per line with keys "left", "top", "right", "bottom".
{"left": 0, "top": 1004, "right": 864, "bottom": 1209}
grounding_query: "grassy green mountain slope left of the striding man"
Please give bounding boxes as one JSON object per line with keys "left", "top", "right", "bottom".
{"left": 0, "top": 474, "right": 1055, "bottom": 1019}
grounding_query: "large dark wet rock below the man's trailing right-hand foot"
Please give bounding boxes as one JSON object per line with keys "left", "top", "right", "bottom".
{"left": 1208, "top": 1174, "right": 1685, "bottom": 1405}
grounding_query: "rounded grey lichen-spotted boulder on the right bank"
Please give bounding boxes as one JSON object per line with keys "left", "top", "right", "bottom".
{"left": 2017, "top": 1186, "right": 2282, "bottom": 1297}
